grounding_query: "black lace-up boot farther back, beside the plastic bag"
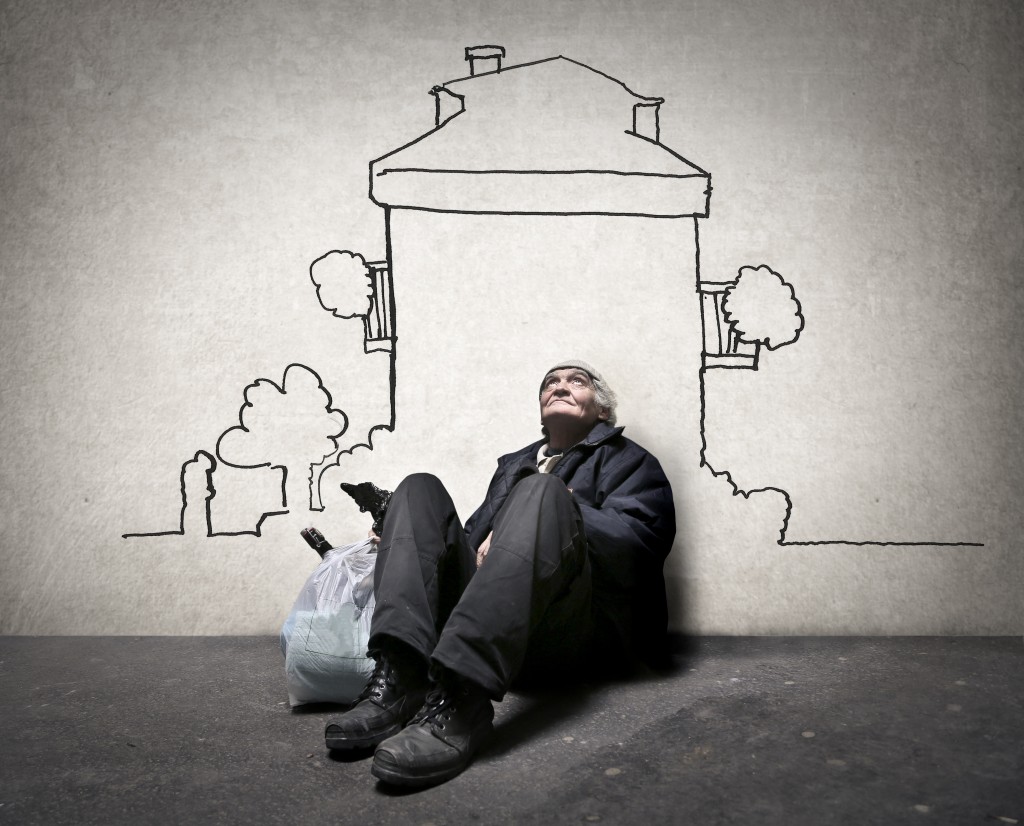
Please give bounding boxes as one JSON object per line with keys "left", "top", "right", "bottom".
{"left": 324, "top": 652, "right": 429, "bottom": 751}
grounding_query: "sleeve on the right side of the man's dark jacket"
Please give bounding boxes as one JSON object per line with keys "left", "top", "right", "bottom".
{"left": 577, "top": 451, "right": 676, "bottom": 591}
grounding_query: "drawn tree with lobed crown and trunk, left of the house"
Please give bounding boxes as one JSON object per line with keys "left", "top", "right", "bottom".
{"left": 217, "top": 364, "right": 348, "bottom": 510}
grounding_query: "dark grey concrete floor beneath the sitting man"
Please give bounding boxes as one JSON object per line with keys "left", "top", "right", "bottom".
{"left": 0, "top": 637, "right": 1024, "bottom": 826}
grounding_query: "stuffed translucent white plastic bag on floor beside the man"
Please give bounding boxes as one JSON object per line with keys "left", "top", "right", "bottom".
{"left": 281, "top": 539, "right": 377, "bottom": 706}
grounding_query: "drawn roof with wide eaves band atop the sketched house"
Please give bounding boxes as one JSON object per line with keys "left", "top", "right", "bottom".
{"left": 370, "top": 56, "right": 711, "bottom": 217}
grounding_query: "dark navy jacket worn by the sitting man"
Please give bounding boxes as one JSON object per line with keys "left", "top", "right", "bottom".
{"left": 466, "top": 422, "right": 676, "bottom": 663}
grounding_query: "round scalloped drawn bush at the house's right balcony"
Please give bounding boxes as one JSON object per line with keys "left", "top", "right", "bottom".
{"left": 722, "top": 264, "right": 804, "bottom": 350}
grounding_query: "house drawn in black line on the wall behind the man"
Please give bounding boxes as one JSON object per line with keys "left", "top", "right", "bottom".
{"left": 356, "top": 46, "right": 779, "bottom": 622}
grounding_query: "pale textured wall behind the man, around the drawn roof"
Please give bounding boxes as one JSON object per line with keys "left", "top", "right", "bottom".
{"left": 0, "top": 0, "right": 1024, "bottom": 635}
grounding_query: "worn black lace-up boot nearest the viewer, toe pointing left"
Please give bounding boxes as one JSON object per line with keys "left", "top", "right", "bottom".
{"left": 370, "top": 682, "right": 495, "bottom": 786}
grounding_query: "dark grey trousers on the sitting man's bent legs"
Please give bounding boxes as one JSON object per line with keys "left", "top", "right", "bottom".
{"left": 370, "top": 474, "right": 593, "bottom": 700}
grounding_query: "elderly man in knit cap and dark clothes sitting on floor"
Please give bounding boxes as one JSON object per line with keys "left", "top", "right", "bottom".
{"left": 325, "top": 360, "right": 676, "bottom": 786}
